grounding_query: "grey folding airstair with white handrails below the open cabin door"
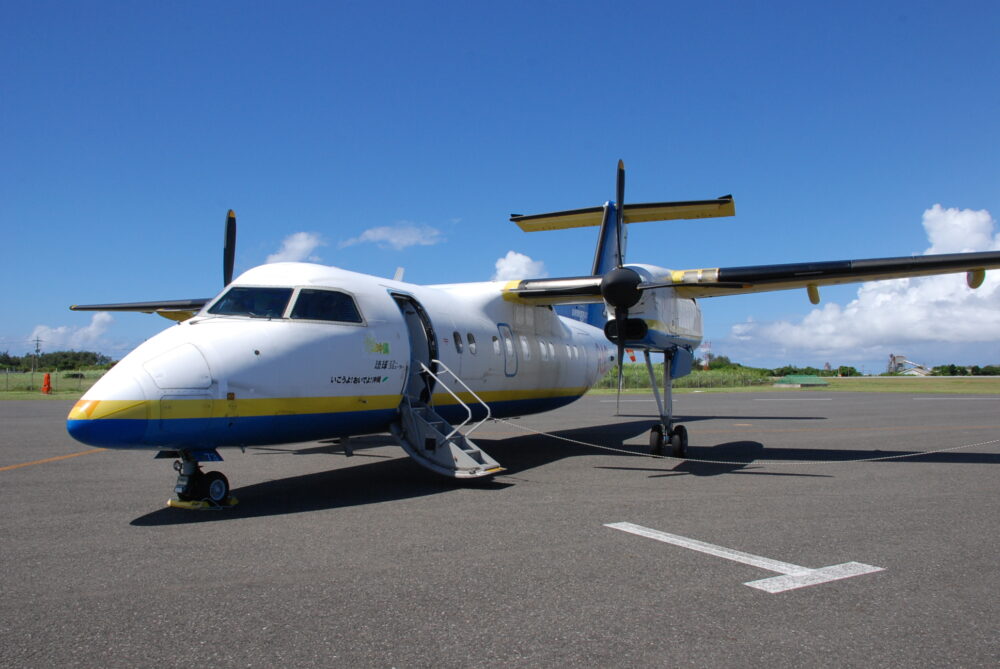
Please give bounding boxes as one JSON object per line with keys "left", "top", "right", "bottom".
{"left": 390, "top": 360, "right": 504, "bottom": 479}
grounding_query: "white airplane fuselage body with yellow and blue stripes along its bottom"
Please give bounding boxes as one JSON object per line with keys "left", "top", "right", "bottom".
{"left": 70, "top": 263, "right": 632, "bottom": 448}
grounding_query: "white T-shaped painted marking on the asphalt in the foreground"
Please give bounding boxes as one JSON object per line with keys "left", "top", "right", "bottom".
{"left": 604, "top": 523, "right": 884, "bottom": 594}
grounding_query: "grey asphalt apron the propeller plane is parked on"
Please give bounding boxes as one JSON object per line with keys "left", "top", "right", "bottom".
{"left": 0, "top": 391, "right": 1000, "bottom": 669}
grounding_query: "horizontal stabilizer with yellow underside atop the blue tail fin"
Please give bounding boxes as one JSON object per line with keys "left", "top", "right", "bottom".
{"left": 510, "top": 195, "right": 736, "bottom": 232}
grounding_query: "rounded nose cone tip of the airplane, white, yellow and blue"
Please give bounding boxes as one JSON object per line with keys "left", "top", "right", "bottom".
{"left": 66, "top": 370, "right": 149, "bottom": 448}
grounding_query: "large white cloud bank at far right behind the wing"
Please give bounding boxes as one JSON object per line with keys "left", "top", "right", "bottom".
{"left": 730, "top": 204, "right": 1000, "bottom": 364}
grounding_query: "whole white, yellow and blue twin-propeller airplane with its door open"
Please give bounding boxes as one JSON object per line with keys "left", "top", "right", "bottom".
{"left": 67, "top": 162, "right": 1000, "bottom": 508}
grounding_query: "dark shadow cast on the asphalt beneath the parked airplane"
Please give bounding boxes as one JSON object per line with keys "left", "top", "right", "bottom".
{"left": 131, "top": 417, "right": 1000, "bottom": 526}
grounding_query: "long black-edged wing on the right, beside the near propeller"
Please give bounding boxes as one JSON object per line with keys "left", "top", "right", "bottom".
{"left": 503, "top": 251, "right": 1000, "bottom": 305}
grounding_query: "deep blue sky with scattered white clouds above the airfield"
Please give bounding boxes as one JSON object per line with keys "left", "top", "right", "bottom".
{"left": 0, "top": 1, "right": 1000, "bottom": 371}
